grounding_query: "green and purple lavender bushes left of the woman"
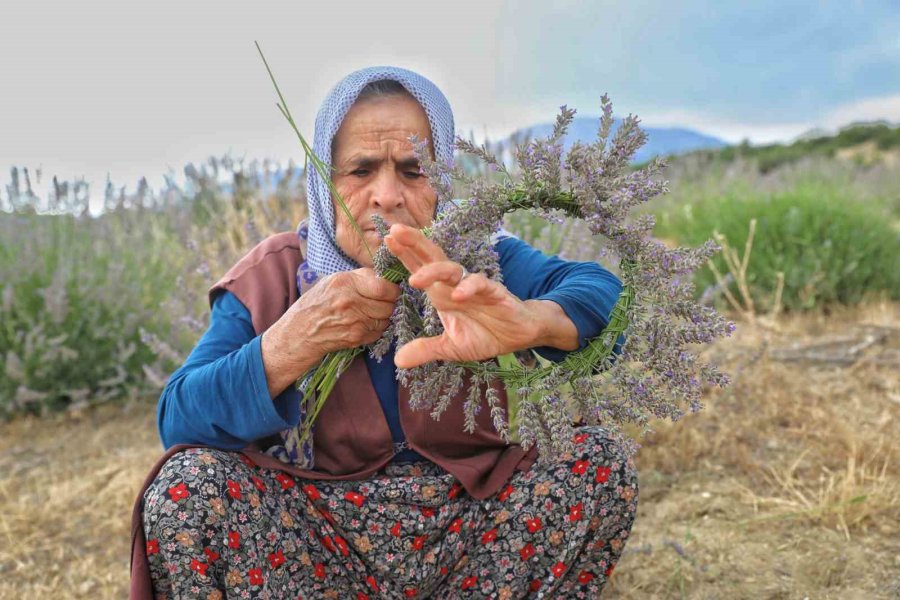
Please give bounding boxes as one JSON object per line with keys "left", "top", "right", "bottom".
{"left": 0, "top": 162, "right": 305, "bottom": 417}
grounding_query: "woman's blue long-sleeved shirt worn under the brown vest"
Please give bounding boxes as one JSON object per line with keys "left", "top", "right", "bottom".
{"left": 157, "top": 233, "right": 622, "bottom": 461}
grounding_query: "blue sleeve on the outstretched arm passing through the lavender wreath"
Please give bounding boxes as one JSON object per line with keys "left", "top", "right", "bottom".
{"left": 496, "top": 237, "right": 623, "bottom": 362}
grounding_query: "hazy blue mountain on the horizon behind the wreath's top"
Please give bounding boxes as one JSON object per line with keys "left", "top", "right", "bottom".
{"left": 511, "top": 117, "right": 728, "bottom": 163}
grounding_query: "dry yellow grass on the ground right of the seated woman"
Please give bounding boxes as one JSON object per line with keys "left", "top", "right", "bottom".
{"left": 605, "top": 303, "right": 900, "bottom": 599}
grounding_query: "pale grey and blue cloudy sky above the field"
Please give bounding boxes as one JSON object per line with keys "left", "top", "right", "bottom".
{"left": 0, "top": 0, "right": 900, "bottom": 204}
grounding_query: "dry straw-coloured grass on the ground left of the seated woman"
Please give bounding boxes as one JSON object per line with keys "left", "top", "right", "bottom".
{"left": 0, "top": 399, "right": 161, "bottom": 599}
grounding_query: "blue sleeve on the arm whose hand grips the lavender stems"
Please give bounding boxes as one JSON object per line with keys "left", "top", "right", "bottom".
{"left": 157, "top": 291, "right": 300, "bottom": 450}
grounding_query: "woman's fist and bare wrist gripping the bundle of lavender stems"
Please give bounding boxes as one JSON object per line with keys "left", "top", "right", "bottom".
{"left": 262, "top": 268, "right": 400, "bottom": 398}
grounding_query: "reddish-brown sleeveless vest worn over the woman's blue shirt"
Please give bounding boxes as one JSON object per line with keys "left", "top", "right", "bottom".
{"left": 209, "top": 232, "right": 537, "bottom": 499}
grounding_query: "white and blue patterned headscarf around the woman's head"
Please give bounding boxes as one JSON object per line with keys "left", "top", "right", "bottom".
{"left": 306, "top": 67, "right": 455, "bottom": 277}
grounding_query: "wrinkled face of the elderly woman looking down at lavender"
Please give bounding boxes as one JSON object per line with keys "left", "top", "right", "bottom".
{"left": 332, "top": 95, "right": 437, "bottom": 267}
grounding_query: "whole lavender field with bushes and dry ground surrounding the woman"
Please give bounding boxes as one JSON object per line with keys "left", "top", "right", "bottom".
{"left": 0, "top": 144, "right": 900, "bottom": 599}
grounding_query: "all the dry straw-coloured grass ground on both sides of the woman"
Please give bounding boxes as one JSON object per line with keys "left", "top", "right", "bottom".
{"left": 0, "top": 304, "right": 900, "bottom": 599}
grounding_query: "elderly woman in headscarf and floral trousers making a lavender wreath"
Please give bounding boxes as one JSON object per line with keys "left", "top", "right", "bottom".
{"left": 132, "top": 67, "right": 637, "bottom": 599}
